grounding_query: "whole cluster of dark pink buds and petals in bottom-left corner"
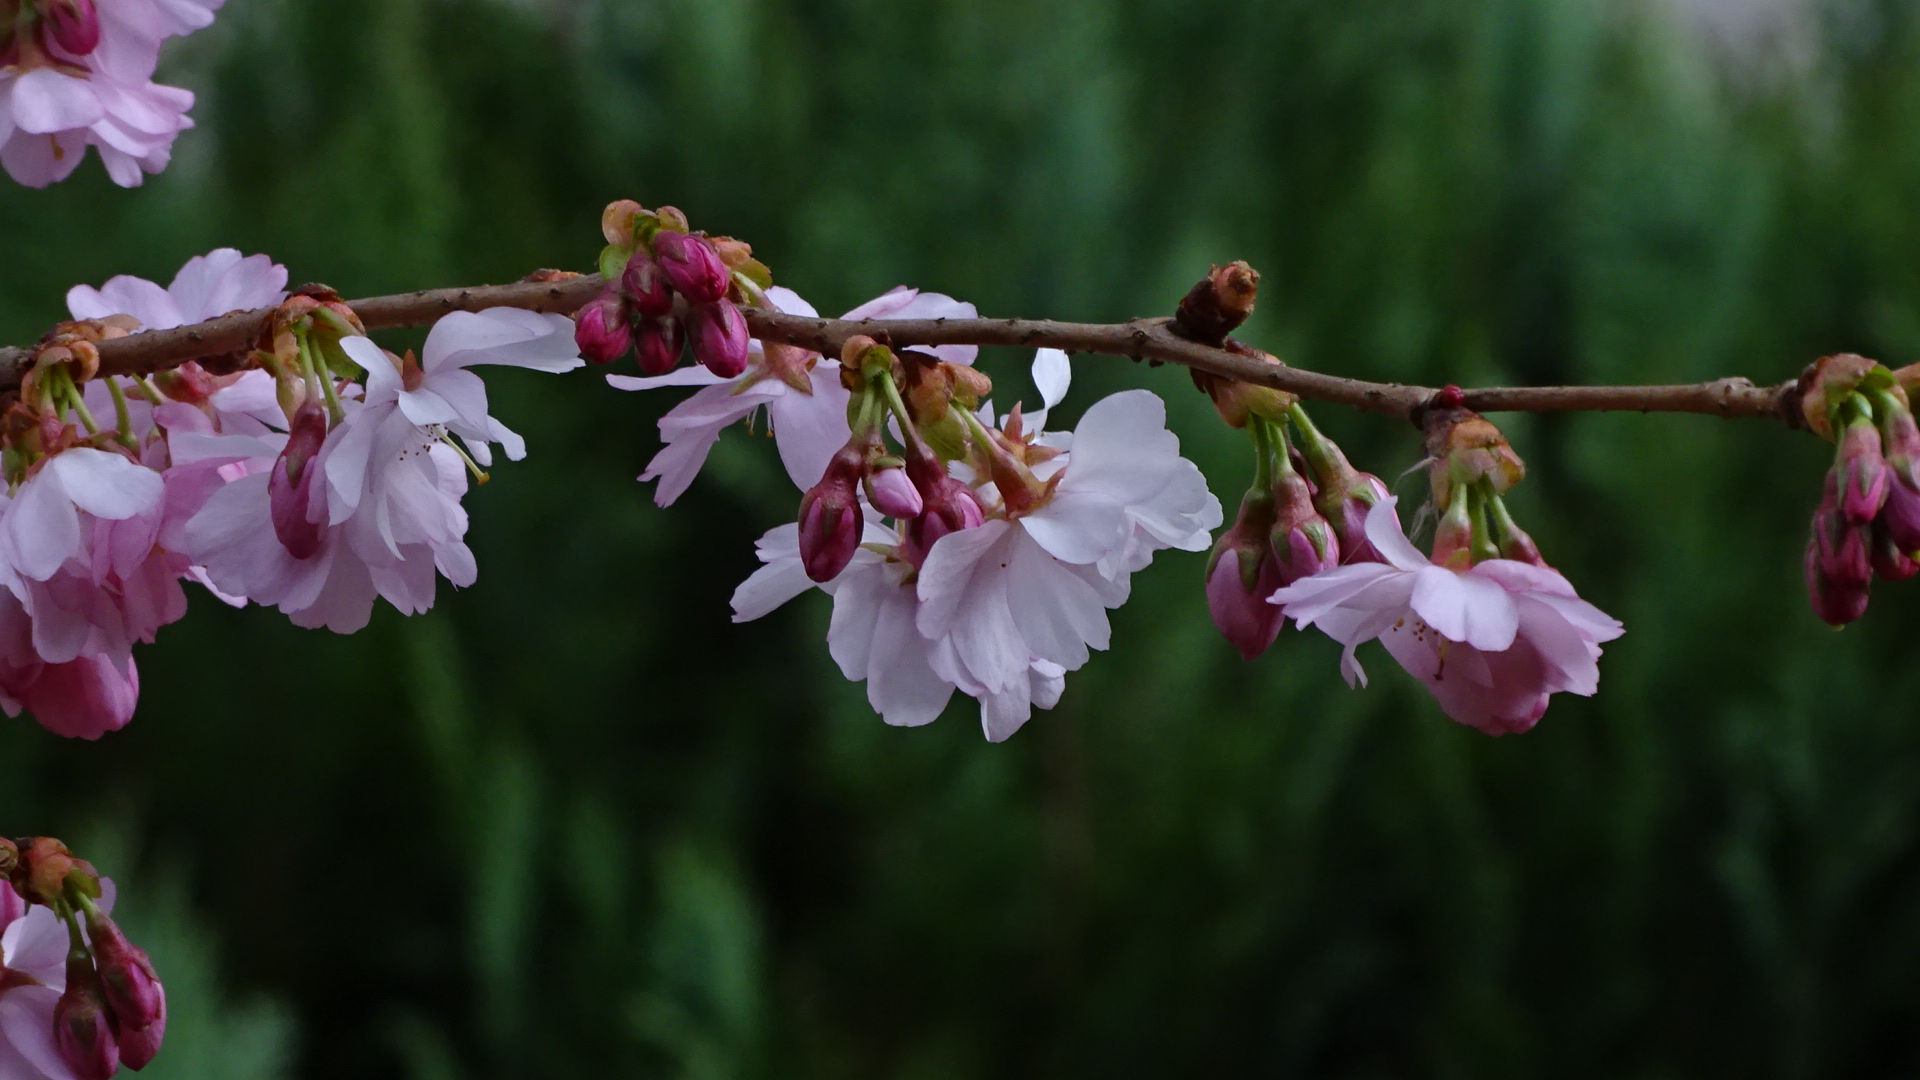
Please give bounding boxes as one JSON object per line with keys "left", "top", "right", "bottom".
{"left": 0, "top": 836, "right": 167, "bottom": 1080}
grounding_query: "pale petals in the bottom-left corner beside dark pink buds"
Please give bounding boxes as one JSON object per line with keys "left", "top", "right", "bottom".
{"left": 0, "top": 878, "right": 115, "bottom": 1080}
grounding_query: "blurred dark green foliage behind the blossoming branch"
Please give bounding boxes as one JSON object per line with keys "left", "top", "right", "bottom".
{"left": 0, "top": 0, "right": 1920, "bottom": 1080}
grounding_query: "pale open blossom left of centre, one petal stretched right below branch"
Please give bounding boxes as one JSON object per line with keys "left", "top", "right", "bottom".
{"left": 185, "top": 309, "right": 586, "bottom": 634}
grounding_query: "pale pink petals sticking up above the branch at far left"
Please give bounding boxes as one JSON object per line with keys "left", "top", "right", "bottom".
{"left": 67, "top": 248, "right": 286, "bottom": 331}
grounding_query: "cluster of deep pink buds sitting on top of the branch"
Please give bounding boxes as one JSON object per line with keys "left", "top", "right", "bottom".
{"left": 574, "top": 200, "right": 774, "bottom": 379}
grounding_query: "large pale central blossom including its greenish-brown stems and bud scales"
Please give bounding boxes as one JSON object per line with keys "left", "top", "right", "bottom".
{"left": 733, "top": 338, "right": 1221, "bottom": 742}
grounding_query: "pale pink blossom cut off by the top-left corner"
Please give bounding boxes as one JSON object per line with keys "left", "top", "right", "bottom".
{"left": 0, "top": 0, "right": 225, "bottom": 186}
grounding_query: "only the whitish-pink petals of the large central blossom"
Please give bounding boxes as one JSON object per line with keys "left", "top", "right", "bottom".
{"left": 733, "top": 363, "right": 1221, "bottom": 742}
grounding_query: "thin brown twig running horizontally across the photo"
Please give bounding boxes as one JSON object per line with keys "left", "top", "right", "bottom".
{"left": 0, "top": 275, "right": 1799, "bottom": 425}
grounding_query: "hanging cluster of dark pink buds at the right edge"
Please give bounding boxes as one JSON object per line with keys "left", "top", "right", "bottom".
{"left": 1799, "top": 354, "right": 1920, "bottom": 626}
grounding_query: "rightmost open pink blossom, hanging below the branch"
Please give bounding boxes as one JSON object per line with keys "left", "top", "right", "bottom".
{"left": 1273, "top": 498, "right": 1620, "bottom": 734}
